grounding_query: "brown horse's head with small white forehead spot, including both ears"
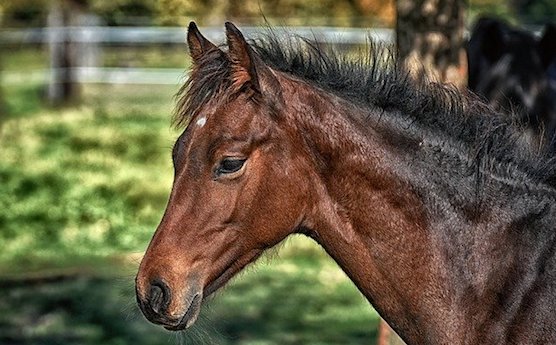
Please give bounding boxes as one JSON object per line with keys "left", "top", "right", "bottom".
{"left": 136, "top": 23, "right": 318, "bottom": 330}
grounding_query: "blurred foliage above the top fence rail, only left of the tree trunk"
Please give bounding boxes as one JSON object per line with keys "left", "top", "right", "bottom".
{"left": 0, "top": 0, "right": 394, "bottom": 27}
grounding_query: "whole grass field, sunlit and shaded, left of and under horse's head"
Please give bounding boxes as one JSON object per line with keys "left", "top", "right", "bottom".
{"left": 0, "top": 72, "right": 378, "bottom": 345}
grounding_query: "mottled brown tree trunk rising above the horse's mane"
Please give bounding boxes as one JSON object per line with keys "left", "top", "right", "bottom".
{"left": 396, "top": 0, "right": 467, "bottom": 88}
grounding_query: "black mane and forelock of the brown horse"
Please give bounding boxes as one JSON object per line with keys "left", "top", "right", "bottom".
{"left": 174, "top": 33, "right": 556, "bottom": 187}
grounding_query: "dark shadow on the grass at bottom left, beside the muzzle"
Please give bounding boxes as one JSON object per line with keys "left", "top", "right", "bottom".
{"left": 0, "top": 276, "right": 168, "bottom": 345}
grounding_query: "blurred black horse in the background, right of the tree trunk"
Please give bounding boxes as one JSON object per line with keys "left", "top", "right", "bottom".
{"left": 467, "top": 17, "right": 556, "bottom": 151}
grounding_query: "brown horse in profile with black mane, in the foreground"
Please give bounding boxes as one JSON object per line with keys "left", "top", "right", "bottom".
{"left": 136, "top": 23, "right": 556, "bottom": 344}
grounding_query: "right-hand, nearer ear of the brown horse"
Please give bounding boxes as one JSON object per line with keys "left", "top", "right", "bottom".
{"left": 226, "top": 22, "right": 279, "bottom": 101}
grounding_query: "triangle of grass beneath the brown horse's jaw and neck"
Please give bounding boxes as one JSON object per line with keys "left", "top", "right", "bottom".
{"left": 208, "top": 238, "right": 378, "bottom": 344}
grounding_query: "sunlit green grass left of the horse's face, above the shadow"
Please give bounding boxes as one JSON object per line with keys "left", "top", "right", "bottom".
{"left": 0, "top": 82, "right": 174, "bottom": 263}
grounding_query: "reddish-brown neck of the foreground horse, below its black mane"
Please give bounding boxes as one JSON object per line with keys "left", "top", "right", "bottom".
{"left": 280, "top": 76, "right": 555, "bottom": 344}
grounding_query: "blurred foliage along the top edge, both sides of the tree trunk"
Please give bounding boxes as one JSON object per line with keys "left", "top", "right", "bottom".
{"left": 0, "top": 0, "right": 556, "bottom": 27}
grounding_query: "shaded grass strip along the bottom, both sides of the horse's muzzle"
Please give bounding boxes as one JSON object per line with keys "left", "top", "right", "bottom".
{"left": 0, "top": 258, "right": 378, "bottom": 345}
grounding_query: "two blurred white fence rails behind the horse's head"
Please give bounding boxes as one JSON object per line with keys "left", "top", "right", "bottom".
{"left": 0, "top": 26, "right": 394, "bottom": 84}
